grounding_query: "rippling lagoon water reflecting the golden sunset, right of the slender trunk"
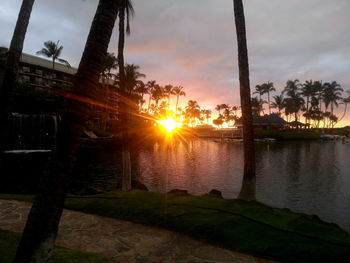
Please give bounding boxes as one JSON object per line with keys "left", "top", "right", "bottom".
{"left": 137, "top": 140, "right": 350, "bottom": 231}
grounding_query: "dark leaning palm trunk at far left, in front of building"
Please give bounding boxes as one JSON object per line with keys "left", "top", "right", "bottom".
{"left": 0, "top": 0, "right": 34, "bottom": 156}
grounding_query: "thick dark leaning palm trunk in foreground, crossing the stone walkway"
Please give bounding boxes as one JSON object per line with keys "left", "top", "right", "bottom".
{"left": 14, "top": 0, "right": 120, "bottom": 263}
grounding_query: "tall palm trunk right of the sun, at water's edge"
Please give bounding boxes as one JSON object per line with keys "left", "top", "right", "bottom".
{"left": 233, "top": 0, "right": 256, "bottom": 200}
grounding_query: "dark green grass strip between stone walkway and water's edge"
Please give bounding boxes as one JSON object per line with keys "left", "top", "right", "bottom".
{"left": 0, "top": 191, "right": 350, "bottom": 262}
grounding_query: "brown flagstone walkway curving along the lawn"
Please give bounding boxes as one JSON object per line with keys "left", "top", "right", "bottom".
{"left": 0, "top": 200, "right": 271, "bottom": 263}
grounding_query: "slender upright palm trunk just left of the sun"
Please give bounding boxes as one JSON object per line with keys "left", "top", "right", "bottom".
{"left": 118, "top": 6, "right": 131, "bottom": 191}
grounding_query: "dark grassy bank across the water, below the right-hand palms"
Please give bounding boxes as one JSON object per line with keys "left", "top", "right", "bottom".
{"left": 254, "top": 130, "right": 321, "bottom": 140}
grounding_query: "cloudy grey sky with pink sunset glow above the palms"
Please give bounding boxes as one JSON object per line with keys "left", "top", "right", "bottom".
{"left": 0, "top": 0, "right": 350, "bottom": 125}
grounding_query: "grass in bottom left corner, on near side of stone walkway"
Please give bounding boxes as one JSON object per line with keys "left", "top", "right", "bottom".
{"left": 0, "top": 229, "right": 117, "bottom": 263}
